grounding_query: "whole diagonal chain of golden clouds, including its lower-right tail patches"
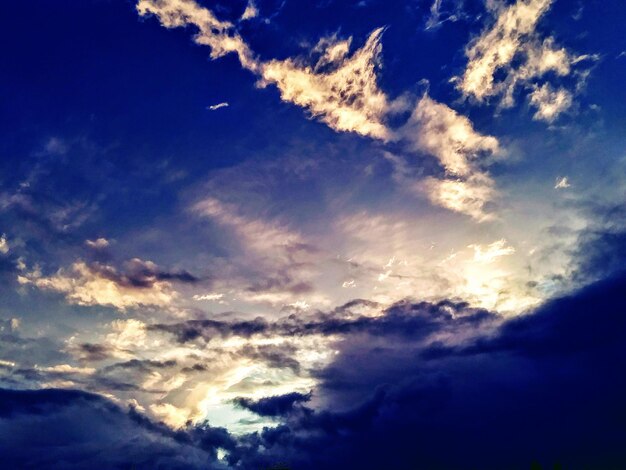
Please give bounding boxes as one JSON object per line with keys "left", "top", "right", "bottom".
{"left": 137, "top": 0, "right": 508, "bottom": 220}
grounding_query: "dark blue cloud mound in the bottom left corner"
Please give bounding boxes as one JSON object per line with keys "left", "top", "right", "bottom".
{"left": 0, "top": 390, "right": 232, "bottom": 469}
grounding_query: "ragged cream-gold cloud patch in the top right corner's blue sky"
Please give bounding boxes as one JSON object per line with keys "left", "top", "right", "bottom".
{"left": 457, "top": 0, "right": 593, "bottom": 122}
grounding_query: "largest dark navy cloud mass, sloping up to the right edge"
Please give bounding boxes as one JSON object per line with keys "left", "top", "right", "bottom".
{"left": 228, "top": 274, "right": 626, "bottom": 469}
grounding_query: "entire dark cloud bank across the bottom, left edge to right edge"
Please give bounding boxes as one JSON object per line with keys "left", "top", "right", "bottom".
{"left": 0, "top": 266, "right": 626, "bottom": 470}
